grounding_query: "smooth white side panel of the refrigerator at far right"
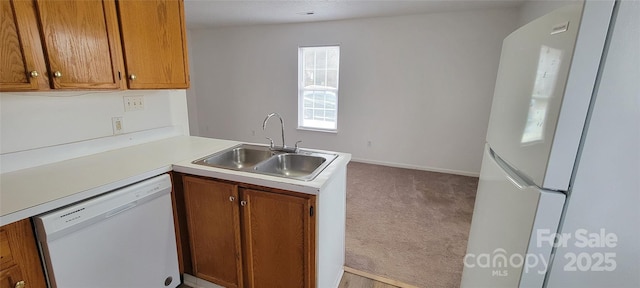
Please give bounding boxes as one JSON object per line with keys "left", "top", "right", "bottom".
{"left": 547, "top": 1, "right": 640, "bottom": 288}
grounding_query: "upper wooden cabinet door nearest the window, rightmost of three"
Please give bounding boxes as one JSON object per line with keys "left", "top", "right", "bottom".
{"left": 118, "top": 0, "right": 189, "bottom": 89}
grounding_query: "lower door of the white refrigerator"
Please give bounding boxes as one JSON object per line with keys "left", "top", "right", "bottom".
{"left": 461, "top": 145, "right": 565, "bottom": 288}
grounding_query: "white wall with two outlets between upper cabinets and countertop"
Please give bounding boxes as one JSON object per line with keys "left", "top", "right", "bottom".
{"left": 0, "top": 90, "right": 189, "bottom": 173}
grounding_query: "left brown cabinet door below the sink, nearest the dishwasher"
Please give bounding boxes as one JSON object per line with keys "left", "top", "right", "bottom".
{"left": 183, "top": 176, "right": 242, "bottom": 287}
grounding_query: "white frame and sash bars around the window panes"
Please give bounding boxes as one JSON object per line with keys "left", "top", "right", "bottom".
{"left": 298, "top": 45, "right": 340, "bottom": 133}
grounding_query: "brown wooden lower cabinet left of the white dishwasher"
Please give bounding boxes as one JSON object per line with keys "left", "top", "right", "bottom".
{"left": 0, "top": 219, "right": 47, "bottom": 288}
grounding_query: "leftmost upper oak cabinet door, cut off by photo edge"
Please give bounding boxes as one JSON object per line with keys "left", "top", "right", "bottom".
{"left": 0, "top": 0, "right": 49, "bottom": 91}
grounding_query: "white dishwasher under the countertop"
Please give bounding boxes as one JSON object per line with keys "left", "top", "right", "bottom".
{"left": 34, "top": 174, "right": 180, "bottom": 288}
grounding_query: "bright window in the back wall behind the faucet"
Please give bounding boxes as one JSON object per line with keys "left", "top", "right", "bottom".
{"left": 298, "top": 46, "right": 340, "bottom": 132}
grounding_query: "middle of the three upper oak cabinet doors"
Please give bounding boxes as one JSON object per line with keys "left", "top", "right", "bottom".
{"left": 37, "top": 0, "right": 122, "bottom": 89}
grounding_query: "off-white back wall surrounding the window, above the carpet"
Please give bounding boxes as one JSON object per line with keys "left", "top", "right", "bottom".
{"left": 189, "top": 9, "right": 518, "bottom": 175}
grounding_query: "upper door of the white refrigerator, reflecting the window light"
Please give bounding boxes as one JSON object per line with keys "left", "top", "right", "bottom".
{"left": 487, "top": 4, "right": 606, "bottom": 191}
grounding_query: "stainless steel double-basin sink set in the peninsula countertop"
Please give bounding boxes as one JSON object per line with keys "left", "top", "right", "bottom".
{"left": 192, "top": 144, "right": 338, "bottom": 181}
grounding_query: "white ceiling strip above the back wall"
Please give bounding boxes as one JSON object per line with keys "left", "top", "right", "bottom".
{"left": 184, "top": 0, "right": 525, "bottom": 29}
